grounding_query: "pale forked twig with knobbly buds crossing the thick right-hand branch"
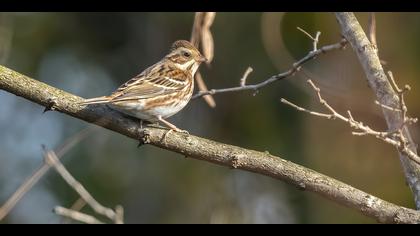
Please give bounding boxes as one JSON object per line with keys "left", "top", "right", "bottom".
{"left": 281, "top": 79, "right": 420, "bottom": 164}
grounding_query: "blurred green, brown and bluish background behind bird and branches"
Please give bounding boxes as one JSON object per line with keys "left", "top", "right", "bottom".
{"left": 0, "top": 12, "right": 420, "bottom": 223}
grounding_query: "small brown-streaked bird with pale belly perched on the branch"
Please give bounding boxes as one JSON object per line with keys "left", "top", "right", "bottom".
{"left": 81, "top": 40, "right": 206, "bottom": 132}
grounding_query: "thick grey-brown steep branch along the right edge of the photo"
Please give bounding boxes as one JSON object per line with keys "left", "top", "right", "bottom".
{"left": 335, "top": 12, "right": 420, "bottom": 209}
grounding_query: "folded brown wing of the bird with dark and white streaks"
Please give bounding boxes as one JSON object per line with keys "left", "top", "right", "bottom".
{"left": 110, "top": 63, "right": 190, "bottom": 102}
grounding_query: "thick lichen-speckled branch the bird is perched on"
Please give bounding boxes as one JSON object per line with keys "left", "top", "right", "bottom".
{"left": 0, "top": 66, "right": 420, "bottom": 223}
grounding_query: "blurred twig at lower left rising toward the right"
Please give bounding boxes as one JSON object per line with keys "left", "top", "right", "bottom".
{"left": 0, "top": 127, "right": 94, "bottom": 221}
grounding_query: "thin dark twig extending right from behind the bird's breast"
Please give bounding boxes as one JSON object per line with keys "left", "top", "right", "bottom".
{"left": 192, "top": 34, "right": 347, "bottom": 99}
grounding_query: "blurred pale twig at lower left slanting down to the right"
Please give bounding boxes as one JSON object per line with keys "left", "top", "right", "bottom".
{"left": 44, "top": 147, "right": 121, "bottom": 222}
